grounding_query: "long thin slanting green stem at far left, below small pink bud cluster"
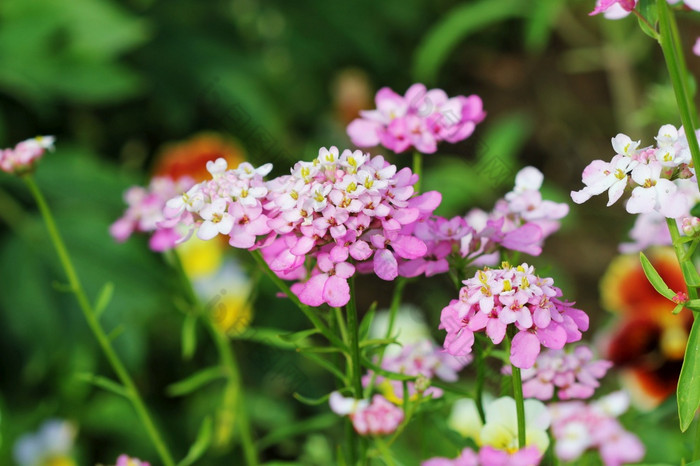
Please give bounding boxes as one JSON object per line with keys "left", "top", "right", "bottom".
{"left": 22, "top": 174, "right": 175, "bottom": 466}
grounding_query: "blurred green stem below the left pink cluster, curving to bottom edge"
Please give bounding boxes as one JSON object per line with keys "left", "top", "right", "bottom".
{"left": 170, "top": 250, "right": 259, "bottom": 466}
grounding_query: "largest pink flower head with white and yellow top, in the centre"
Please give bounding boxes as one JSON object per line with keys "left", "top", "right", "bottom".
{"left": 262, "top": 147, "right": 441, "bottom": 306}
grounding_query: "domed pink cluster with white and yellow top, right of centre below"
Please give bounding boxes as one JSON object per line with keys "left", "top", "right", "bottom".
{"left": 440, "top": 262, "right": 588, "bottom": 369}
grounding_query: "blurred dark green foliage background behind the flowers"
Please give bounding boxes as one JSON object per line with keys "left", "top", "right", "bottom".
{"left": 0, "top": 0, "right": 700, "bottom": 465}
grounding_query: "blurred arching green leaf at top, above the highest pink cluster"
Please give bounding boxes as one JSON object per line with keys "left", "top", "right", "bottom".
{"left": 413, "top": 0, "right": 529, "bottom": 84}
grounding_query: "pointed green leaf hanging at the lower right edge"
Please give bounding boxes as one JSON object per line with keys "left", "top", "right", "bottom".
{"left": 677, "top": 318, "right": 700, "bottom": 432}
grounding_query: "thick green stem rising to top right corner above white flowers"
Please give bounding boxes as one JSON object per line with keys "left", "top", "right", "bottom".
{"left": 656, "top": 0, "right": 700, "bottom": 193}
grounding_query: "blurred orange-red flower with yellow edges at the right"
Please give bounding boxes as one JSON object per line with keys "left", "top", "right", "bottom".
{"left": 600, "top": 248, "right": 693, "bottom": 409}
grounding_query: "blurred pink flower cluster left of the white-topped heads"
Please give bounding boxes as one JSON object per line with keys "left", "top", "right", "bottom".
{"left": 109, "top": 177, "right": 194, "bottom": 252}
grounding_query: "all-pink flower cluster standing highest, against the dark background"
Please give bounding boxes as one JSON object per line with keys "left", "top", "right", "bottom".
{"left": 347, "top": 84, "right": 486, "bottom": 154}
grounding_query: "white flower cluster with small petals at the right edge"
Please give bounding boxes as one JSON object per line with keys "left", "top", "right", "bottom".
{"left": 571, "top": 125, "right": 700, "bottom": 218}
